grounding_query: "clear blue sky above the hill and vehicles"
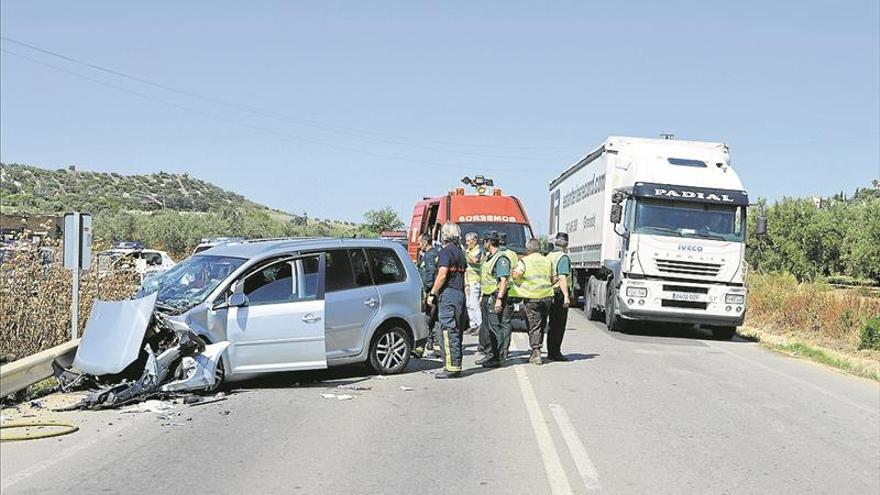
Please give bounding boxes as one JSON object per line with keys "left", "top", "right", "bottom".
{"left": 0, "top": 0, "right": 880, "bottom": 232}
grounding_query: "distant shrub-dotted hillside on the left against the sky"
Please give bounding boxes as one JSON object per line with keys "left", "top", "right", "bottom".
{"left": 0, "top": 163, "right": 295, "bottom": 220}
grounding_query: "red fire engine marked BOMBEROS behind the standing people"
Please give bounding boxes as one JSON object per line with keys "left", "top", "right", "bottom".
{"left": 408, "top": 175, "right": 533, "bottom": 260}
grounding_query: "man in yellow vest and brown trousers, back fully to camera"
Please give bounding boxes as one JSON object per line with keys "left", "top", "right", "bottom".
{"left": 513, "top": 239, "right": 553, "bottom": 364}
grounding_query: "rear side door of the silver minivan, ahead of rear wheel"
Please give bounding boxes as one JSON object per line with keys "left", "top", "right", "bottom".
{"left": 326, "top": 249, "right": 380, "bottom": 359}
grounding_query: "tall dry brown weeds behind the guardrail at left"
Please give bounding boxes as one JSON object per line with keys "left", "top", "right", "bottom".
{"left": 0, "top": 251, "right": 139, "bottom": 358}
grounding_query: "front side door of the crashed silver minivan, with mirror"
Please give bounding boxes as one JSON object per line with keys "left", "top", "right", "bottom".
{"left": 226, "top": 254, "right": 327, "bottom": 373}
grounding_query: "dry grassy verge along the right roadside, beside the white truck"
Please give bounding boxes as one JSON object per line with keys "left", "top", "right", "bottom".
{"left": 743, "top": 273, "right": 880, "bottom": 379}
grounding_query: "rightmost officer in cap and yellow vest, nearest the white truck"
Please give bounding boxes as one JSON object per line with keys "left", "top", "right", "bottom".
{"left": 547, "top": 232, "right": 571, "bottom": 361}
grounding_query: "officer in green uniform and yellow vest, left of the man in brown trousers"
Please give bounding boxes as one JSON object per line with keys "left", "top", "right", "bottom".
{"left": 477, "top": 231, "right": 513, "bottom": 368}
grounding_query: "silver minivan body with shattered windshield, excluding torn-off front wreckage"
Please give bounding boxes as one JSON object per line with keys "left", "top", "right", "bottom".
{"left": 139, "top": 238, "right": 428, "bottom": 380}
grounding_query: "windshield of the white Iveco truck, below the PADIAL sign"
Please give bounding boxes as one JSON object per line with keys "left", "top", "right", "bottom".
{"left": 634, "top": 199, "right": 745, "bottom": 242}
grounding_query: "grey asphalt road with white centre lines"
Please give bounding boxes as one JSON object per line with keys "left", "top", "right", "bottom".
{"left": 0, "top": 311, "right": 880, "bottom": 495}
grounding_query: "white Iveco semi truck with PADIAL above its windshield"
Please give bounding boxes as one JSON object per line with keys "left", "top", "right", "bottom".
{"left": 550, "top": 137, "right": 766, "bottom": 339}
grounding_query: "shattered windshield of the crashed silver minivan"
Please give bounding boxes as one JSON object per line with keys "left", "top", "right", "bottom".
{"left": 139, "top": 255, "right": 246, "bottom": 311}
